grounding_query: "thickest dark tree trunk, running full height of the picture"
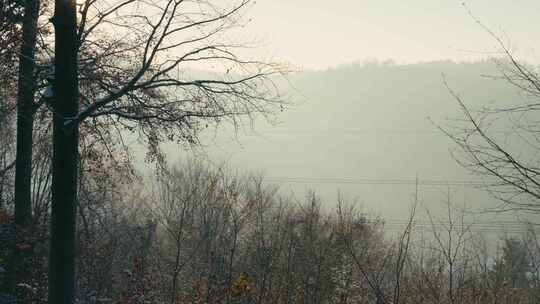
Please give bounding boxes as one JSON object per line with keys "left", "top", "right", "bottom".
{"left": 49, "top": 0, "right": 79, "bottom": 304}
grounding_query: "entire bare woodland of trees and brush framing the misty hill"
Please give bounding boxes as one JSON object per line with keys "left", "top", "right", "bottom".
{"left": 0, "top": 0, "right": 540, "bottom": 304}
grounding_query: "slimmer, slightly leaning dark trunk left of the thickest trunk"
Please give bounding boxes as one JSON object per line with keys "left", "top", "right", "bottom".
{"left": 4, "top": 0, "right": 40, "bottom": 292}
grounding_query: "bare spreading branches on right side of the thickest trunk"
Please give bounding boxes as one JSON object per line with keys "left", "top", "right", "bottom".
{"left": 70, "top": 0, "right": 283, "bottom": 151}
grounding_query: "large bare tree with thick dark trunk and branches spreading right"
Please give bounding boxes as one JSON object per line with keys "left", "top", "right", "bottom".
{"left": 44, "top": 0, "right": 280, "bottom": 303}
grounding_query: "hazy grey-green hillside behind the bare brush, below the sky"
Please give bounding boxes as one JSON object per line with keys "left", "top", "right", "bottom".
{"left": 134, "top": 61, "right": 524, "bottom": 233}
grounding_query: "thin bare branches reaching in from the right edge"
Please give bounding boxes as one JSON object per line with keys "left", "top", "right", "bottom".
{"left": 441, "top": 8, "right": 540, "bottom": 213}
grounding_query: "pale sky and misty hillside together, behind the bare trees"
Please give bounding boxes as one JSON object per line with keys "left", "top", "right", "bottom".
{"left": 129, "top": 0, "right": 540, "bottom": 233}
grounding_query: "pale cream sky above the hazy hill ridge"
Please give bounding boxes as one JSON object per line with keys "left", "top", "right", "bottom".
{"left": 247, "top": 0, "right": 540, "bottom": 69}
